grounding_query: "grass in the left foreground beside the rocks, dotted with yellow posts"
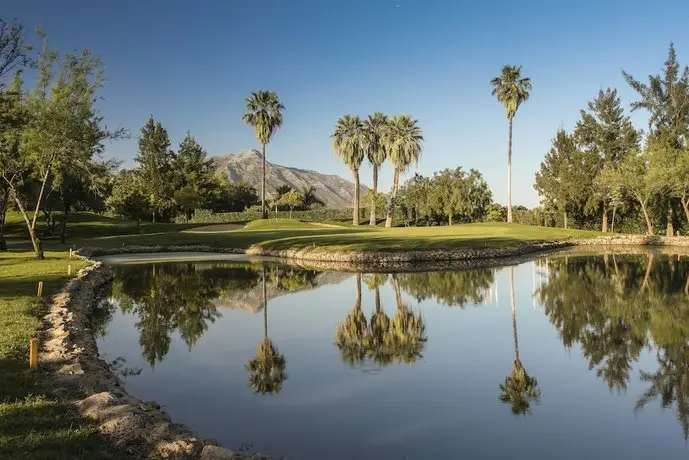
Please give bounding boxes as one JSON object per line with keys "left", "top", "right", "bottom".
{"left": 0, "top": 252, "right": 117, "bottom": 460}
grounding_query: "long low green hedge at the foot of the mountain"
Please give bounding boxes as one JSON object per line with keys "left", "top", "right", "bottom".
{"left": 175, "top": 208, "right": 354, "bottom": 224}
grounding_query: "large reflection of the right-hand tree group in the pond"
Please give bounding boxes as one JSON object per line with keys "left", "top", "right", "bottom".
{"left": 538, "top": 252, "right": 689, "bottom": 439}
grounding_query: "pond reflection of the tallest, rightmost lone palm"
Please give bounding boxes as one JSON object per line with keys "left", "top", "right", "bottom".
{"left": 499, "top": 267, "right": 541, "bottom": 415}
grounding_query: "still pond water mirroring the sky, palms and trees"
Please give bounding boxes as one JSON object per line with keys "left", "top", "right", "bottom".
{"left": 94, "top": 253, "right": 689, "bottom": 460}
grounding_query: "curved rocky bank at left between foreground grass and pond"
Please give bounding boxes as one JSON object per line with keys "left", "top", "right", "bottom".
{"left": 40, "top": 261, "right": 268, "bottom": 460}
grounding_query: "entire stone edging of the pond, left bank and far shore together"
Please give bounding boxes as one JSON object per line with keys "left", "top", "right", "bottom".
{"left": 59, "top": 235, "right": 689, "bottom": 460}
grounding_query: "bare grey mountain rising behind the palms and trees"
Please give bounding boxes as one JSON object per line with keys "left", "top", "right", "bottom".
{"left": 213, "top": 150, "right": 367, "bottom": 208}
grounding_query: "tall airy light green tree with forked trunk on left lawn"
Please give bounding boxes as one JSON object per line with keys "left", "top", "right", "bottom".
{"left": 15, "top": 37, "right": 124, "bottom": 259}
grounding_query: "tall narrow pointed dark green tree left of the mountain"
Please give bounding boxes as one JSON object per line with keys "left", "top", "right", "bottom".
{"left": 135, "top": 116, "right": 174, "bottom": 223}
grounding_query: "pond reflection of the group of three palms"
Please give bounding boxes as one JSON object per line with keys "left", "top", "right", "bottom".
{"left": 335, "top": 273, "right": 427, "bottom": 366}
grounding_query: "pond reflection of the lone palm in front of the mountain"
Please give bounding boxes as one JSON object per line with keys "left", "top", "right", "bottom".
{"left": 244, "top": 266, "right": 287, "bottom": 394}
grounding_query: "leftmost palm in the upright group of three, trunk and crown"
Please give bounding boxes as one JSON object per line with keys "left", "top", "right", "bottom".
{"left": 330, "top": 115, "right": 366, "bottom": 225}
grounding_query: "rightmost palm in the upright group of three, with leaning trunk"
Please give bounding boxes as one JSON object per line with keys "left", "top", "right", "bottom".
{"left": 383, "top": 115, "right": 423, "bottom": 228}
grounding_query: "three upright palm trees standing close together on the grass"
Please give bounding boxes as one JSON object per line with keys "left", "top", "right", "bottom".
{"left": 331, "top": 112, "right": 423, "bottom": 228}
